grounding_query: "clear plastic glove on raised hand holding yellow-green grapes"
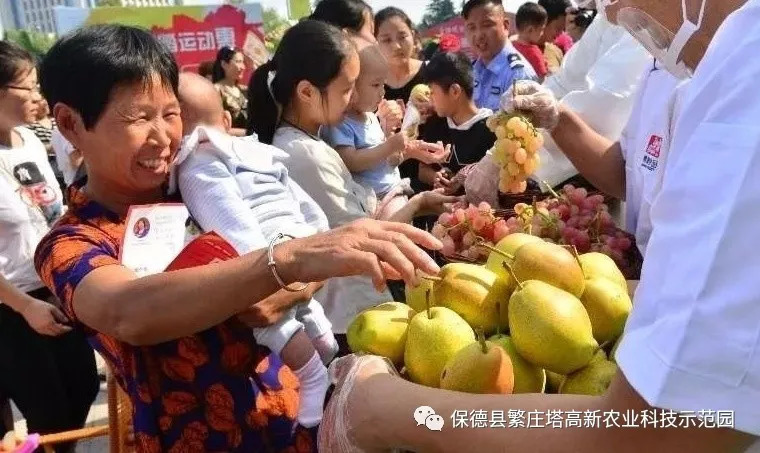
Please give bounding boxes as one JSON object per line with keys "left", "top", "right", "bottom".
{"left": 501, "top": 80, "right": 559, "bottom": 131}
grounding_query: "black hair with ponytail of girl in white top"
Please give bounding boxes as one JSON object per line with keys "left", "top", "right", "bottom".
{"left": 248, "top": 20, "right": 354, "bottom": 144}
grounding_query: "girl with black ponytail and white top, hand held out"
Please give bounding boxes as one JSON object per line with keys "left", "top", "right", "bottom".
{"left": 248, "top": 20, "right": 457, "bottom": 342}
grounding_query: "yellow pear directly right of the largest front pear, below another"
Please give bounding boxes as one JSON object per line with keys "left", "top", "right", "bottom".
{"left": 581, "top": 277, "right": 633, "bottom": 343}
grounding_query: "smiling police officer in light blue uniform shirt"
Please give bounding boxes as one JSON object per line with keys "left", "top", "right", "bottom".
{"left": 462, "top": 0, "right": 537, "bottom": 111}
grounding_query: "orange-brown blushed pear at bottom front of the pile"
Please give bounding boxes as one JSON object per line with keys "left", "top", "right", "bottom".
{"left": 441, "top": 338, "right": 514, "bottom": 394}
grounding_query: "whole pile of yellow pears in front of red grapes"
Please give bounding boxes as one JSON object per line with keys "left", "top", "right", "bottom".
{"left": 347, "top": 233, "right": 632, "bottom": 395}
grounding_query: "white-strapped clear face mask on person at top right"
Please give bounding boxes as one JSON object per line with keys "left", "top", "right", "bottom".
{"left": 616, "top": 0, "right": 707, "bottom": 79}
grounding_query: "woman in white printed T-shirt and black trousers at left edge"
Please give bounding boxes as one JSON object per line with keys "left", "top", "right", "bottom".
{"left": 0, "top": 41, "right": 99, "bottom": 451}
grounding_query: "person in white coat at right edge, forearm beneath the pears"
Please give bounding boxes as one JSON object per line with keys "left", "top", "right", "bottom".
{"left": 319, "top": 0, "right": 760, "bottom": 453}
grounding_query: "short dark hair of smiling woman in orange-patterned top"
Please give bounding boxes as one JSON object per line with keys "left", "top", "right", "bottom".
{"left": 40, "top": 24, "right": 179, "bottom": 129}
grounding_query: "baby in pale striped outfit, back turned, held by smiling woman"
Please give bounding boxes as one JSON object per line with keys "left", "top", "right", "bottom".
{"left": 170, "top": 73, "right": 338, "bottom": 428}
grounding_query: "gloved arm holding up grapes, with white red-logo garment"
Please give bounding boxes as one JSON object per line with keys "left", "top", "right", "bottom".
{"left": 503, "top": 60, "right": 688, "bottom": 256}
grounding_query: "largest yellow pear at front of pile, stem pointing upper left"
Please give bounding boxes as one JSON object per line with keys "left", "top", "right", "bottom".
{"left": 509, "top": 280, "right": 599, "bottom": 374}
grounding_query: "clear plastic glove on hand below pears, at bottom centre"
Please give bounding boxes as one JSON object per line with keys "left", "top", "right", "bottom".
{"left": 317, "top": 354, "right": 398, "bottom": 453}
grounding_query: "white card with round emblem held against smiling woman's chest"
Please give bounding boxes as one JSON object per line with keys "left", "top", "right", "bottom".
{"left": 120, "top": 203, "right": 200, "bottom": 277}
